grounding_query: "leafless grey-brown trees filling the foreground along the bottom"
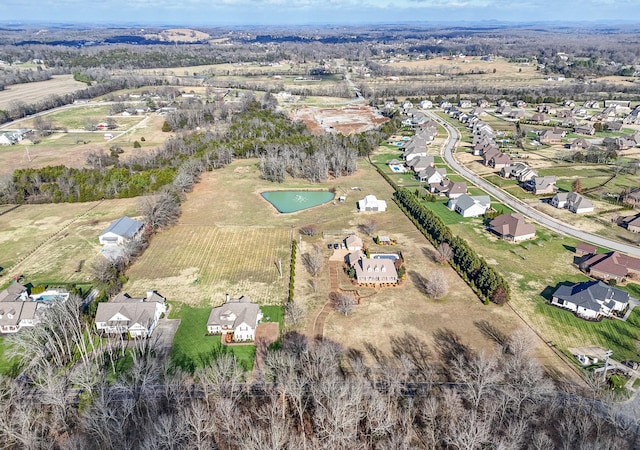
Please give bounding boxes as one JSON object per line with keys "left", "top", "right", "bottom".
{"left": 0, "top": 304, "right": 637, "bottom": 450}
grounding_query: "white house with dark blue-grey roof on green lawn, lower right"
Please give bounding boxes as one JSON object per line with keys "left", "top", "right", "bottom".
{"left": 551, "top": 281, "right": 629, "bottom": 319}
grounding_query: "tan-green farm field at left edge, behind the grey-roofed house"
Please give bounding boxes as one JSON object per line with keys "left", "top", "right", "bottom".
{"left": 0, "top": 199, "right": 137, "bottom": 285}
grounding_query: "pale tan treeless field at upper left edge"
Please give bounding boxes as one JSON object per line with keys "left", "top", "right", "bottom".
{"left": 0, "top": 75, "right": 87, "bottom": 110}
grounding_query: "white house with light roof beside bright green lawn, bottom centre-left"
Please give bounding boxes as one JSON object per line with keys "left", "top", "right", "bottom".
{"left": 207, "top": 294, "right": 262, "bottom": 342}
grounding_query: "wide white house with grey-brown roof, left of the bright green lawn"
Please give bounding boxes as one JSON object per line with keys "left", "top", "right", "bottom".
{"left": 95, "top": 291, "right": 167, "bottom": 338}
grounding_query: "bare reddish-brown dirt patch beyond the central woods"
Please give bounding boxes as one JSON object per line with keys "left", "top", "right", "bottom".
{"left": 291, "top": 106, "right": 389, "bottom": 135}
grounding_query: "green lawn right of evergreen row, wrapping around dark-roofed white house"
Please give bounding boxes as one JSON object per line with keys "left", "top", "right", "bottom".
{"left": 438, "top": 211, "right": 640, "bottom": 359}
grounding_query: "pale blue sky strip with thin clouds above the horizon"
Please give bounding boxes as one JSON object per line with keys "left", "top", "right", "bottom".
{"left": 0, "top": 0, "right": 640, "bottom": 27}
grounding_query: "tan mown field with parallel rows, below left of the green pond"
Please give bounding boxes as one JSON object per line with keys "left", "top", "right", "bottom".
{"left": 127, "top": 225, "right": 291, "bottom": 306}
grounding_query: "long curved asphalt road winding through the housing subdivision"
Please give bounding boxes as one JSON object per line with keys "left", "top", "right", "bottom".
{"left": 425, "top": 111, "right": 640, "bottom": 257}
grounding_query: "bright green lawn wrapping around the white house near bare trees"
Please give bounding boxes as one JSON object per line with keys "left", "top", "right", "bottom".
{"left": 170, "top": 304, "right": 256, "bottom": 372}
